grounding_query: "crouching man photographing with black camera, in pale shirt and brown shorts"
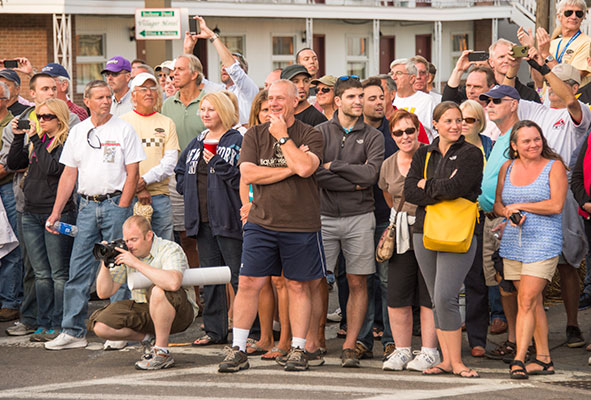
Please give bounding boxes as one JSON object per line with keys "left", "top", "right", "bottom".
{"left": 88, "top": 215, "right": 198, "bottom": 370}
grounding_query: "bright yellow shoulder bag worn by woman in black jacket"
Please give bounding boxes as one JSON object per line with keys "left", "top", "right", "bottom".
{"left": 423, "top": 152, "right": 478, "bottom": 253}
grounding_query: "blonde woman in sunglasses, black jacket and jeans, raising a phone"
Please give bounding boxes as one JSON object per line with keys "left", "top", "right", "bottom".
{"left": 7, "top": 99, "right": 76, "bottom": 342}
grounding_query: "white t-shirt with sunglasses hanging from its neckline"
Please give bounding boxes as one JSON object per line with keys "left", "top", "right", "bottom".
{"left": 60, "top": 116, "right": 146, "bottom": 196}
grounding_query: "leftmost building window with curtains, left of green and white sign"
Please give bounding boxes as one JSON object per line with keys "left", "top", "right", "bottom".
{"left": 76, "top": 34, "right": 106, "bottom": 93}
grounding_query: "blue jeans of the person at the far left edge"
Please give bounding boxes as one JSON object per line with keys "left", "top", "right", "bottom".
{"left": 0, "top": 182, "right": 23, "bottom": 310}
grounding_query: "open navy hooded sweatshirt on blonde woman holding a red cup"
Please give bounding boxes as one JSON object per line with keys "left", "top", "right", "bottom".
{"left": 174, "top": 129, "right": 242, "bottom": 239}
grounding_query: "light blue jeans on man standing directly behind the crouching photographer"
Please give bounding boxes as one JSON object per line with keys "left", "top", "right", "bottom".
{"left": 62, "top": 196, "right": 131, "bottom": 337}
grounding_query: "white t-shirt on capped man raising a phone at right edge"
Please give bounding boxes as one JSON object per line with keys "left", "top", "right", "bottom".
{"left": 518, "top": 100, "right": 591, "bottom": 165}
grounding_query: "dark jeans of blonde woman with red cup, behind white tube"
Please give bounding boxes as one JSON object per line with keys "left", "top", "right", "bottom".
{"left": 197, "top": 222, "right": 242, "bottom": 342}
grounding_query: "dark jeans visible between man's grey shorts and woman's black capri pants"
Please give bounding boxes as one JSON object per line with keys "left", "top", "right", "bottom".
{"left": 357, "top": 222, "right": 394, "bottom": 350}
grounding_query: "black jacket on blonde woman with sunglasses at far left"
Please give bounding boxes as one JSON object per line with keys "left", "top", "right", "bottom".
{"left": 6, "top": 134, "right": 75, "bottom": 214}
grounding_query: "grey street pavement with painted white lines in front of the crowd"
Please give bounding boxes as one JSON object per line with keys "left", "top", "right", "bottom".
{"left": 0, "top": 293, "right": 591, "bottom": 400}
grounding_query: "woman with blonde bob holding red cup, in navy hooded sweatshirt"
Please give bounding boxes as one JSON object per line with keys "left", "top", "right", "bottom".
{"left": 174, "top": 92, "right": 242, "bottom": 346}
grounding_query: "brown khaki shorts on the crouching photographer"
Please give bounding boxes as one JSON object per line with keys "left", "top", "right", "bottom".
{"left": 87, "top": 288, "right": 194, "bottom": 334}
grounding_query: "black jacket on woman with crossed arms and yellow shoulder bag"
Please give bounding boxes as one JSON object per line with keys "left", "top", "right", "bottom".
{"left": 404, "top": 136, "right": 484, "bottom": 233}
